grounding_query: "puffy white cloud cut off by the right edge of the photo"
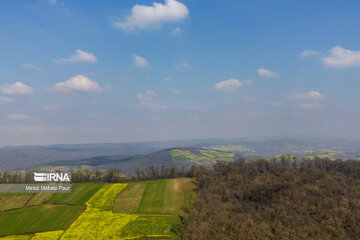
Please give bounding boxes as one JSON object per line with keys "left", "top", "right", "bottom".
{"left": 321, "top": 46, "right": 360, "bottom": 68}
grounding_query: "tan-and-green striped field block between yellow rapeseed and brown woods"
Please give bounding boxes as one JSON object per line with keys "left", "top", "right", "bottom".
{"left": 113, "top": 178, "right": 196, "bottom": 214}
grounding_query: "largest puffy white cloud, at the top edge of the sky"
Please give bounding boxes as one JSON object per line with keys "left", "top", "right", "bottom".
{"left": 113, "top": 0, "right": 189, "bottom": 31}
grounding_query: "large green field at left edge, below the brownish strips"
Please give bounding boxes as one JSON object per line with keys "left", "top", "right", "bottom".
{"left": 0, "top": 205, "right": 85, "bottom": 237}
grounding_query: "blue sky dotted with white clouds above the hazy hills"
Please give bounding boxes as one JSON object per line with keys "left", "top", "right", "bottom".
{"left": 0, "top": 0, "right": 360, "bottom": 145}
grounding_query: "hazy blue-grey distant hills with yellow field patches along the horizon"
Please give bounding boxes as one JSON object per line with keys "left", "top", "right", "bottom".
{"left": 0, "top": 136, "right": 360, "bottom": 170}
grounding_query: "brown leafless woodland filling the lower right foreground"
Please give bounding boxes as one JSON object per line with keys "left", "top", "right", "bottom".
{"left": 181, "top": 158, "right": 360, "bottom": 240}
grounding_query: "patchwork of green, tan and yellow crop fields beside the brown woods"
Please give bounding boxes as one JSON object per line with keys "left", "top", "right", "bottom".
{"left": 0, "top": 179, "right": 196, "bottom": 240}
